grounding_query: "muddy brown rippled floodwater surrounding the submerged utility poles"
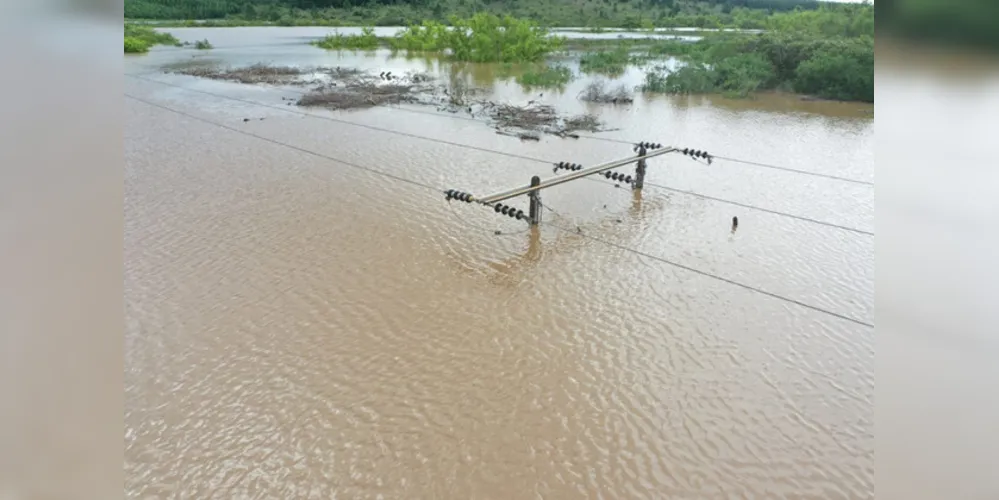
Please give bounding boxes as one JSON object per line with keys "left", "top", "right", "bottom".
{"left": 124, "top": 28, "right": 875, "bottom": 499}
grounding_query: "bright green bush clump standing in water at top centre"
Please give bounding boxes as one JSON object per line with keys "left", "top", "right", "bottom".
{"left": 391, "top": 13, "right": 562, "bottom": 62}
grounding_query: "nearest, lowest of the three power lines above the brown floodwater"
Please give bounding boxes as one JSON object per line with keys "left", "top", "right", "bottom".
{"left": 124, "top": 94, "right": 874, "bottom": 328}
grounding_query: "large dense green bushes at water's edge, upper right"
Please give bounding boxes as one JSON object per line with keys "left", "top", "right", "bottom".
{"left": 643, "top": 5, "right": 874, "bottom": 102}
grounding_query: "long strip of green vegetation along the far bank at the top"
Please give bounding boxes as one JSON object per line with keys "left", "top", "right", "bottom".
{"left": 125, "top": 0, "right": 819, "bottom": 29}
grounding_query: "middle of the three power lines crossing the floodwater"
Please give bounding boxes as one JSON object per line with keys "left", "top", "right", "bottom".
{"left": 126, "top": 75, "right": 874, "bottom": 236}
